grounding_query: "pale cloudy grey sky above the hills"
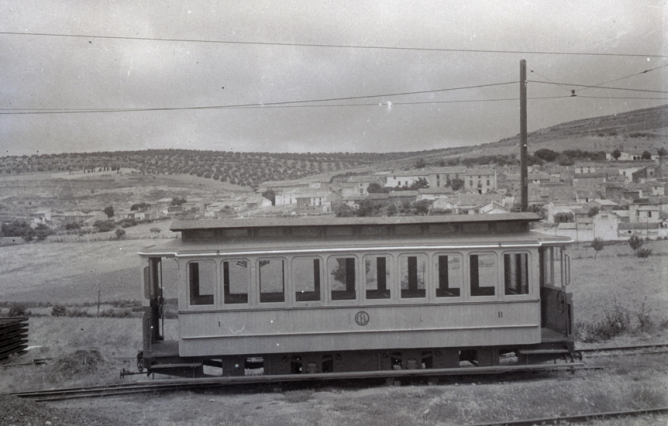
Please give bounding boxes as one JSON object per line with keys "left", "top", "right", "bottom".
{"left": 0, "top": 0, "right": 668, "bottom": 156}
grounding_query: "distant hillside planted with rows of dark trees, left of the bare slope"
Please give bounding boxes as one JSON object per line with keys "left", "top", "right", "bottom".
{"left": 0, "top": 148, "right": 468, "bottom": 188}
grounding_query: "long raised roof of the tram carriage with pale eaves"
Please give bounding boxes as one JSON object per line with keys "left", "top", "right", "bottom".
{"left": 140, "top": 213, "right": 571, "bottom": 256}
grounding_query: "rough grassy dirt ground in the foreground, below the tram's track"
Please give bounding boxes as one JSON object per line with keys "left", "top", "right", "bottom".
{"left": 0, "top": 354, "right": 668, "bottom": 426}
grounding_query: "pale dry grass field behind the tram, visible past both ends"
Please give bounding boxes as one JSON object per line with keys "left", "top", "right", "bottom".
{"left": 0, "top": 238, "right": 668, "bottom": 325}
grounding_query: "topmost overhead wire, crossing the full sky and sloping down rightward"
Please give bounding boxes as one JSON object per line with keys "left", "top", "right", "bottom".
{"left": 0, "top": 31, "right": 668, "bottom": 58}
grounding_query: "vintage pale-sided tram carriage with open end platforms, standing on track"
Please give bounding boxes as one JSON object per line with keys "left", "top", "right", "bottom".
{"left": 139, "top": 213, "right": 574, "bottom": 377}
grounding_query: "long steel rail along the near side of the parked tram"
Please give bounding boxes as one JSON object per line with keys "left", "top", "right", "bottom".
{"left": 12, "top": 363, "right": 586, "bottom": 402}
